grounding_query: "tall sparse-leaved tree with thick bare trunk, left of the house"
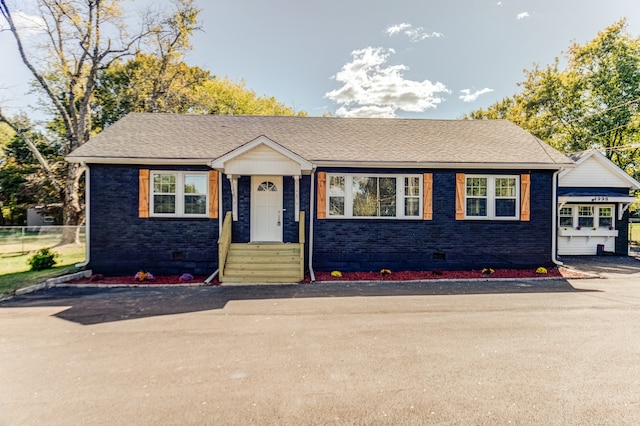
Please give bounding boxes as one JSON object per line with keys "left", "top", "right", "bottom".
{"left": 0, "top": 0, "right": 199, "bottom": 242}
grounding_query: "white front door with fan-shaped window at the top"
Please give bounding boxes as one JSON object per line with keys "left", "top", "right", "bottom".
{"left": 251, "top": 176, "right": 283, "bottom": 242}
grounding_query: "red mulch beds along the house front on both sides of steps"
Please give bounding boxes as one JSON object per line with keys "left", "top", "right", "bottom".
{"left": 68, "top": 267, "right": 590, "bottom": 285}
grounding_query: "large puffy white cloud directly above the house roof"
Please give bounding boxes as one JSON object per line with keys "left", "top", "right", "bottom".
{"left": 325, "top": 47, "right": 451, "bottom": 117}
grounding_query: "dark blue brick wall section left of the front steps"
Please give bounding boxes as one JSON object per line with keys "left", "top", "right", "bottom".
{"left": 89, "top": 165, "right": 218, "bottom": 275}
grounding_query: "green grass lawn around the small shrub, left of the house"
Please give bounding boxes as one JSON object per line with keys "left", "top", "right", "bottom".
{"left": 0, "top": 244, "right": 85, "bottom": 295}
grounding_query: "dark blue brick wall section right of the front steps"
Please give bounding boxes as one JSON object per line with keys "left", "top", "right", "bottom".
{"left": 313, "top": 170, "right": 553, "bottom": 271}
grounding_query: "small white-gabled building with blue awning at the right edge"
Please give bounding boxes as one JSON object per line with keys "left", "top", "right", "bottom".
{"left": 558, "top": 149, "right": 640, "bottom": 255}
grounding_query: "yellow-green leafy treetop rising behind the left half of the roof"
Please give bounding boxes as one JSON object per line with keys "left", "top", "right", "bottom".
{"left": 92, "top": 53, "right": 306, "bottom": 130}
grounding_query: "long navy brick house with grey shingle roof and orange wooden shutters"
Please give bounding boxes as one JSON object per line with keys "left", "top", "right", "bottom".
{"left": 67, "top": 113, "right": 574, "bottom": 282}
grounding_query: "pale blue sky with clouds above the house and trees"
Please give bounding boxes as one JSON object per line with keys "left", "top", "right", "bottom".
{"left": 0, "top": 0, "right": 640, "bottom": 119}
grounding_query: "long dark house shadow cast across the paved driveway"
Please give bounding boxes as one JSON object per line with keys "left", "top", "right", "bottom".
{"left": 0, "top": 279, "right": 591, "bottom": 325}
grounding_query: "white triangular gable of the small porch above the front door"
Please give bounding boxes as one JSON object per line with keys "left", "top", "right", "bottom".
{"left": 209, "top": 135, "right": 313, "bottom": 176}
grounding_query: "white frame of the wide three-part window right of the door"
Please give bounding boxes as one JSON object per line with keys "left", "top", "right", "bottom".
{"left": 326, "top": 173, "right": 424, "bottom": 220}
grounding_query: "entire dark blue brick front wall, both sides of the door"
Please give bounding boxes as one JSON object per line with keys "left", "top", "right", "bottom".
{"left": 90, "top": 165, "right": 556, "bottom": 275}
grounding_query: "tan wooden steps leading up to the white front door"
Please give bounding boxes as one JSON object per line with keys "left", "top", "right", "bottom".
{"left": 219, "top": 243, "right": 304, "bottom": 284}
